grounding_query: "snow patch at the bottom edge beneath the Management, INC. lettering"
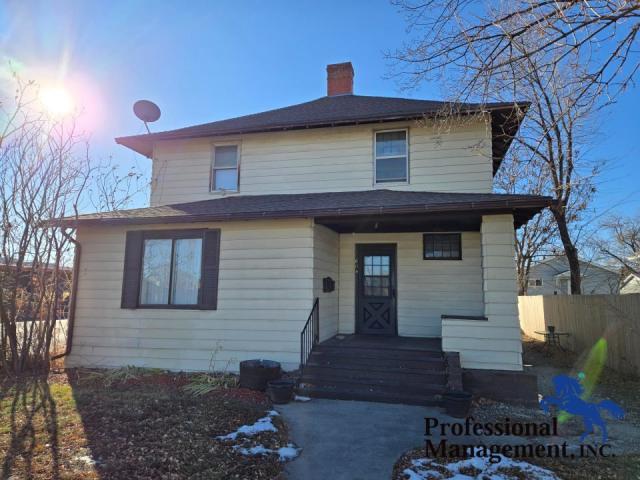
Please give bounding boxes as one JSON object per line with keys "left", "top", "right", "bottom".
{"left": 403, "top": 455, "right": 560, "bottom": 480}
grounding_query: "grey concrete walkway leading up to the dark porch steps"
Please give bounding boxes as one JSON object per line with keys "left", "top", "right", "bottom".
{"left": 277, "top": 399, "right": 449, "bottom": 480}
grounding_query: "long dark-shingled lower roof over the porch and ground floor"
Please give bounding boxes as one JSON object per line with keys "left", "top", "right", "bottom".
{"left": 49, "top": 189, "right": 552, "bottom": 229}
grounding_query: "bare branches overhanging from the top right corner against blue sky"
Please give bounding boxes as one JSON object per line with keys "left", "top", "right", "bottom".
{"left": 392, "top": 0, "right": 640, "bottom": 98}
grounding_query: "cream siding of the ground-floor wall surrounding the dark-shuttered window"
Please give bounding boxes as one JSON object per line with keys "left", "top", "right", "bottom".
{"left": 68, "top": 219, "right": 314, "bottom": 370}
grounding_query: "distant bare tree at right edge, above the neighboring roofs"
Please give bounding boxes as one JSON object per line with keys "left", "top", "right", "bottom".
{"left": 596, "top": 215, "right": 640, "bottom": 276}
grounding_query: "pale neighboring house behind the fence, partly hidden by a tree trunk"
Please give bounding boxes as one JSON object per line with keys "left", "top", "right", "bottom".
{"left": 526, "top": 255, "right": 620, "bottom": 295}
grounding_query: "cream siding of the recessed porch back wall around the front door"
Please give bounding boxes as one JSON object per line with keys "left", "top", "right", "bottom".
{"left": 339, "top": 232, "right": 484, "bottom": 337}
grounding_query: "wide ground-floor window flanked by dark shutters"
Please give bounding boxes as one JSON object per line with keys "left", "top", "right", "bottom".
{"left": 122, "top": 230, "right": 220, "bottom": 310}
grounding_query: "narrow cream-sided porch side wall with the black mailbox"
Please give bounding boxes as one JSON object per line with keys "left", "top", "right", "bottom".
{"left": 313, "top": 225, "right": 340, "bottom": 341}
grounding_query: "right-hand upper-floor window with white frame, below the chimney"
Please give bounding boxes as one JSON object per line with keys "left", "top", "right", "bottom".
{"left": 375, "top": 130, "right": 409, "bottom": 183}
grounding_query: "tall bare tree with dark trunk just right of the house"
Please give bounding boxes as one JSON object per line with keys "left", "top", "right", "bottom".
{"left": 393, "top": 0, "right": 605, "bottom": 294}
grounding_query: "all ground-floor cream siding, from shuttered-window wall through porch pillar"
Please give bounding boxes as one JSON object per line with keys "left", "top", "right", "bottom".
{"left": 68, "top": 215, "right": 522, "bottom": 370}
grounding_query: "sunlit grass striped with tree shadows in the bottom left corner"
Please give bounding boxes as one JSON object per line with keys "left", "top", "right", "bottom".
{"left": 0, "top": 378, "right": 60, "bottom": 479}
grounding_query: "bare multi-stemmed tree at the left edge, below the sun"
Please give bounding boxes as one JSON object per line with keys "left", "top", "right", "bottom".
{"left": 0, "top": 72, "right": 146, "bottom": 374}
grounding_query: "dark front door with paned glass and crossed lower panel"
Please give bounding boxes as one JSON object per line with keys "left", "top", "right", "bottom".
{"left": 356, "top": 243, "right": 398, "bottom": 335}
